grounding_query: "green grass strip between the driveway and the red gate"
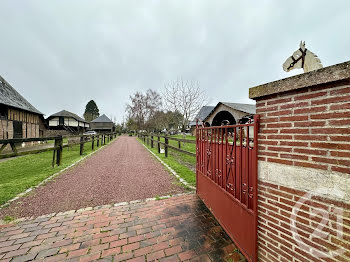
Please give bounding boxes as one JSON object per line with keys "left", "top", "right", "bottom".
{"left": 139, "top": 139, "right": 196, "bottom": 186}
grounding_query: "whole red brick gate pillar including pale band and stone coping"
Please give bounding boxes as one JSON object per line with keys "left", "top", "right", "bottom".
{"left": 250, "top": 62, "right": 350, "bottom": 262}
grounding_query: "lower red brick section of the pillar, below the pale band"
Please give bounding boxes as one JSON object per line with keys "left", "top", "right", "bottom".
{"left": 258, "top": 182, "right": 350, "bottom": 262}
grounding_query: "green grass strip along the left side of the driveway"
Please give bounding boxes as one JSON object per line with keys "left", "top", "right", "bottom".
{"left": 0, "top": 138, "right": 117, "bottom": 205}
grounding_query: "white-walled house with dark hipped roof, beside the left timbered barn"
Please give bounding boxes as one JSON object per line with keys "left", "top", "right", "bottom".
{"left": 46, "top": 110, "right": 90, "bottom": 133}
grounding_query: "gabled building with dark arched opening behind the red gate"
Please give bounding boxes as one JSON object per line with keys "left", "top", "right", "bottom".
{"left": 203, "top": 102, "right": 256, "bottom": 126}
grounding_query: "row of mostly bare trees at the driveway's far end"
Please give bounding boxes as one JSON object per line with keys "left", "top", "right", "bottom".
{"left": 126, "top": 79, "right": 206, "bottom": 131}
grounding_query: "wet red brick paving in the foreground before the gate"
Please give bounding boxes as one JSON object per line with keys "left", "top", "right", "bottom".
{"left": 0, "top": 194, "right": 245, "bottom": 262}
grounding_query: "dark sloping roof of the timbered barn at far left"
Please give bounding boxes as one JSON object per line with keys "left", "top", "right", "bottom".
{"left": 0, "top": 76, "right": 43, "bottom": 115}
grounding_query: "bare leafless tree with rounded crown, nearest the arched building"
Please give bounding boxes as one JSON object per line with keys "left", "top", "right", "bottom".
{"left": 163, "top": 79, "right": 206, "bottom": 131}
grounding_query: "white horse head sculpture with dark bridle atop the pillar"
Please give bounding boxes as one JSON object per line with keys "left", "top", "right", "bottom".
{"left": 283, "top": 41, "right": 323, "bottom": 73}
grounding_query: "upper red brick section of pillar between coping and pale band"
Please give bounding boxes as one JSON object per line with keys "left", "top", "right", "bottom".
{"left": 256, "top": 82, "right": 350, "bottom": 173}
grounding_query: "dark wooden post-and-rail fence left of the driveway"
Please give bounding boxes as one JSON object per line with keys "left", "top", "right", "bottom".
{"left": 0, "top": 133, "right": 117, "bottom": 167}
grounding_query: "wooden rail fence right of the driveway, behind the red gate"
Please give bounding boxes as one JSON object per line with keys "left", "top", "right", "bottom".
{"left": 138, "top": 134, "right": 196, "bottom": 157}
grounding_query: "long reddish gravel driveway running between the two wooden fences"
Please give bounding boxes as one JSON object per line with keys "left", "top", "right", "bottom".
{"left": 0, "top": 136, "right": 184, "bottom": 218}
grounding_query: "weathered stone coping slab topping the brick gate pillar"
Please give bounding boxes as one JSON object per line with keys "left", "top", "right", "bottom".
{"left": 249, "top": 61, "right": 350, "bottom": 99}
